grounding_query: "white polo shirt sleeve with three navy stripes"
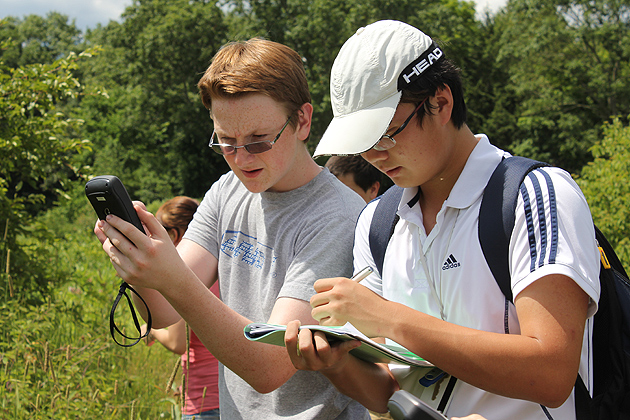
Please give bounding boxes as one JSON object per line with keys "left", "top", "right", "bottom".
{"left": 510, "top": 168, "right": 600, "bottom": 316}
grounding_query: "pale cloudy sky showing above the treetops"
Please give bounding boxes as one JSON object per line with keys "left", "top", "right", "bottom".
{"left": 0, "top": 0, "right": 506, "bottom": 31}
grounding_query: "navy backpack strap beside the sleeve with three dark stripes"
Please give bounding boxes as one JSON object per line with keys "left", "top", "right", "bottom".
{"left": 479, "top": 156, "right": 549, "bottom": 302}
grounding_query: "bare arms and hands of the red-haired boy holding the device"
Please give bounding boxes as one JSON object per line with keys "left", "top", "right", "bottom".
{"left": 97, "top": 206, "right": 315, "bottom": 393}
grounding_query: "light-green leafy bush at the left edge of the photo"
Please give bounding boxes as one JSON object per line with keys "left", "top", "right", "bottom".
{"left": 0, "top": 41, "right": 102, "bottom": 300}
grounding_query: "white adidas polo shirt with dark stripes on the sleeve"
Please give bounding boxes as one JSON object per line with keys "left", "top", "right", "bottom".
{"left": 354, "top": 135, "right": 600, "bottom": 420}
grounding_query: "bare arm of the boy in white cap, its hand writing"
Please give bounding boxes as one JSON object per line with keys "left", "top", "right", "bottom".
{"left": 311, "top": 275, "right": 588, "bottom": 407}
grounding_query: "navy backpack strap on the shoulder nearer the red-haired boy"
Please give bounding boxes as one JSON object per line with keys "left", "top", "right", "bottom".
{"left": 368, "top": 185, "right": 404, "bottom": 275}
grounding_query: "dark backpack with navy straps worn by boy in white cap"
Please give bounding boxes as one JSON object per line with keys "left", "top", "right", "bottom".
{"left": 369, "top": 157, "right": 630, "bottom": 420}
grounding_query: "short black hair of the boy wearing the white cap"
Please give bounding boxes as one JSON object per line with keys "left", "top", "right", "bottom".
{"left": 400, "top": 50, "right": 467, "bottom": 128}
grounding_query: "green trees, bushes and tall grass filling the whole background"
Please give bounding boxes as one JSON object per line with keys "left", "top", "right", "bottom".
{"left": 0, "top": 0, "right": 630, "bottom": 419}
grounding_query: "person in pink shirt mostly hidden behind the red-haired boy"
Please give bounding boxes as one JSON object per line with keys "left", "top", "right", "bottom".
{"left": 142, "top": 196, "right": 219, "bottom": 420}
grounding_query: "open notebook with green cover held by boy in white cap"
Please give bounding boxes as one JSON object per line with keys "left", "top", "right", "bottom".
{"left": 243, "top": 323, "right": 433, "bottom": 367}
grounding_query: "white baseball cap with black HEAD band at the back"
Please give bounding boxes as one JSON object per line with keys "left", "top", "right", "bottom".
{"left": 313, "top": 20, "right": 444, "bottom": 157}
